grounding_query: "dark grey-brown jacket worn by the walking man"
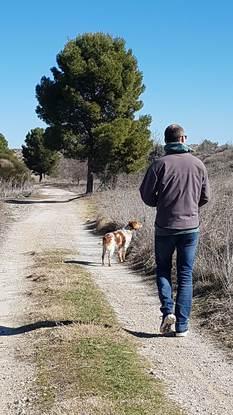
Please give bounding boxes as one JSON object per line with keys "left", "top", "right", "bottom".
{"left": 140, "top": 153, "right": 209, "bottom": 229}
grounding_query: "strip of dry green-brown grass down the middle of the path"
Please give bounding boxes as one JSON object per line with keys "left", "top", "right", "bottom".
{"left": 25, "top": 251, "right": 183, "bottom": 415}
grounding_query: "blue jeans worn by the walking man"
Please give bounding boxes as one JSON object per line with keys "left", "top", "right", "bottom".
{"left": 155, "top": 232, "right": 199, "bottom": 332}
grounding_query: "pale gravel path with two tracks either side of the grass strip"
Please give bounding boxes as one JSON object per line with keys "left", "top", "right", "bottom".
{"left": 0, "top": 187, "right": 233, "bottom": 415}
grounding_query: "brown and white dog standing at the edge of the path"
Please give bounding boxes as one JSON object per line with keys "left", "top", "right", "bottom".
{"left": 102, "top": 220, "right": 142, "bottom": 267}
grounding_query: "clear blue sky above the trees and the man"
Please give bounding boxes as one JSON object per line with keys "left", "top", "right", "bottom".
{"left": 0, "top": 0, "right": 233, "bottom": 148}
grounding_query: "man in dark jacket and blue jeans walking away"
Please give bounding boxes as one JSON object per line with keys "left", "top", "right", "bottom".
{"left": 140, "top": 124, "right": 209, "bottom": 337}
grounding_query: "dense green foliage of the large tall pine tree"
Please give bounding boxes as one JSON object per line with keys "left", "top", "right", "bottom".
{"left": 36, "top": 33, "right": 151, "bottom": 192}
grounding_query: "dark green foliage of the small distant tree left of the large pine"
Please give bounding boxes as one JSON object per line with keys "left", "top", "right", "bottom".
{"left": 22, "top": 128, "right": 58, "bottom": 180}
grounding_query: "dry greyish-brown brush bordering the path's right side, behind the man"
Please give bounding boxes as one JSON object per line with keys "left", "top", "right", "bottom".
{"left": 95, "top": 147, "right": 233, "bottom": 347}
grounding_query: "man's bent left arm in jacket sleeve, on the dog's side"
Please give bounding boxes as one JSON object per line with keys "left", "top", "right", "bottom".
{"left": 139, "top": 165, "right": 158, "bottom": 207}
